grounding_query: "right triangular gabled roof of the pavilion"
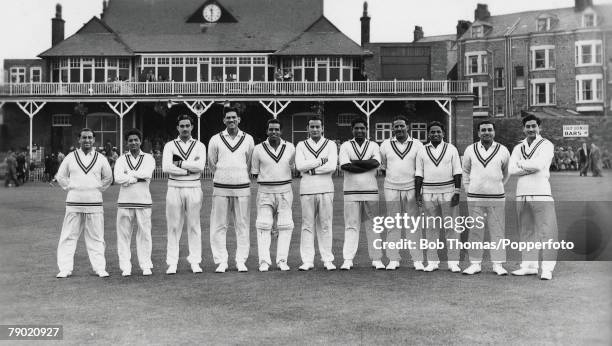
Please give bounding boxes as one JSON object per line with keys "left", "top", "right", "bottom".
{"left": 274, "top": 16, "right": 366, "bottom": 55}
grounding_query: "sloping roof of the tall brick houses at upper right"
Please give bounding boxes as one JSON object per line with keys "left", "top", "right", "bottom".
{"left": 461, "top": 5, "right": 612, "bottom": 39}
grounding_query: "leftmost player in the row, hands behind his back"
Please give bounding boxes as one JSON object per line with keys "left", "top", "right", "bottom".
{"left": 55, "top": 128, "right": 113, "bottom": 278}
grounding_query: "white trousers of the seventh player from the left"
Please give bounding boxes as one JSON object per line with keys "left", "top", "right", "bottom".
{"left": 342, "top": 201, "right": 382, "bottom": 261}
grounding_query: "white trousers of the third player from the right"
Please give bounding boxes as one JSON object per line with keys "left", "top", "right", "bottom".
{"left": 423, "top": 192, "right": 459, "bottom": 265}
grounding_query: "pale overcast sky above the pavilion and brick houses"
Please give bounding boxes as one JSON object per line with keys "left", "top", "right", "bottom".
{"left": 0, "top": 0, "right": 612, "bottom": 80}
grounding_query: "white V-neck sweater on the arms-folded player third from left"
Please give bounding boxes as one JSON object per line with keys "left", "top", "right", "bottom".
{"left": 162, "top": 137, "right": 206, "bottom": 187}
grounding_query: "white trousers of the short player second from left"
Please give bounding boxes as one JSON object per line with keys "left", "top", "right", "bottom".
{"left": 117, "top": 208, "right": 153, "bottom": 272}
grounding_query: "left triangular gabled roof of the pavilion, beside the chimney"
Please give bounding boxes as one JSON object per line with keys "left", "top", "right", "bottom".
{"left": 39, "top": 17, "right": 133, "bottom": 57}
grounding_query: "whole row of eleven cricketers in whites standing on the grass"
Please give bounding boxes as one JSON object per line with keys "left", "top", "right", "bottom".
{"left": 56, "top": 108, "right": 557, "bottom": 280}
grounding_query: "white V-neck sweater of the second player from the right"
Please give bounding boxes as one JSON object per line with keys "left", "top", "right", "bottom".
{"left": 462, "top": 141, "right": 510, "bottom": 201}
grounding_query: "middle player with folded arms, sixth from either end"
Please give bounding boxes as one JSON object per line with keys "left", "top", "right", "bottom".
{"left": 295, "top": 116, "right": 338, "bottom": 270}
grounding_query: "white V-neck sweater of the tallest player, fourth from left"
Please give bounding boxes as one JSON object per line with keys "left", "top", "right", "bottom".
{"left": 208, "top": 130, "right": 255, "bottom": 197}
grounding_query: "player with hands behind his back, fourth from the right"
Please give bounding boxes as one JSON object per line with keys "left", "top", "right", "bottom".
{"left": 380, "top": 116, "right": 425, "bottom": 271}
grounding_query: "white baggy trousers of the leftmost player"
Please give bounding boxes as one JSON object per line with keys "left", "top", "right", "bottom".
{"left": 57, "top": 212, "right": 106, "bottom": 273}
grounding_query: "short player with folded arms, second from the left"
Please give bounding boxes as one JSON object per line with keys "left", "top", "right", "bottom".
{"left": 114, "top": 129, "right": 155, "bottom": 276}
